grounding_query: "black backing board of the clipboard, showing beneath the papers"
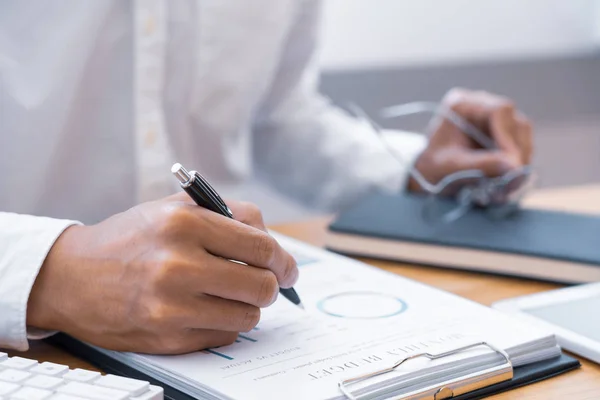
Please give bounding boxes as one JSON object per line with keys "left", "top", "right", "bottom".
{"left": 46, "top": 334, "right": 581, "bottom": 400}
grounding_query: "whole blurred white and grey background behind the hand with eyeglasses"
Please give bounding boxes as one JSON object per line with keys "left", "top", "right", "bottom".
{"left": 258, "top": 0, "right": 600, "bottom": 222}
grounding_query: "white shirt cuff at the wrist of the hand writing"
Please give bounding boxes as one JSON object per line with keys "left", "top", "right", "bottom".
{"left": 0, "top": 212, "right": 79, "bottom": 351}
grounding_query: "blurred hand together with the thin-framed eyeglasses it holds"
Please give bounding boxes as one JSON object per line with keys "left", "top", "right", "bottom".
{"left": 352, "top": 89, "right": 534, "bottom": 222}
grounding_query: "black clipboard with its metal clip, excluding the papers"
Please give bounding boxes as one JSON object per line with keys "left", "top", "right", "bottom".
{"left": 45, "top": 333, "right": 581, "bottom": 400}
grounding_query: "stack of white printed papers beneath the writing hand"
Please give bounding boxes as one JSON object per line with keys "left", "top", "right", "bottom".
{"left": 91, "top": 235, "right": 560, "bottom": 400}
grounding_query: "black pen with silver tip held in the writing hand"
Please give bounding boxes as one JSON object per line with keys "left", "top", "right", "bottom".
{"left": 171, "top": 163, "right": 304, "bottom": 308}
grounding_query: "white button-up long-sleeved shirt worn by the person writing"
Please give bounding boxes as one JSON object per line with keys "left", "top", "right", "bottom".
{"left": 0, "top": 0, "right": 424, "bottom": 350}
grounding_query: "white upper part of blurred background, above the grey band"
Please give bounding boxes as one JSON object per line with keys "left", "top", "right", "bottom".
{"left": 321, "top": 0, "right": 600, "bottom": 70}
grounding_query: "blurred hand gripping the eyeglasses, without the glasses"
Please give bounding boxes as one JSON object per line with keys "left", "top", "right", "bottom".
{"left": 409, "top": 89, "right": 533, "bottom": 191}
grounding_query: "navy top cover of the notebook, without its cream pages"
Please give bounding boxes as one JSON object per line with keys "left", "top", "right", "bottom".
{"left": 329, "top": 194, "right": 600, "bottom": 267}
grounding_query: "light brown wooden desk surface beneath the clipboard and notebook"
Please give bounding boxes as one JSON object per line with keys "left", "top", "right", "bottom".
{"left": 8, "top": 185, "right": 600, "bottom": 400}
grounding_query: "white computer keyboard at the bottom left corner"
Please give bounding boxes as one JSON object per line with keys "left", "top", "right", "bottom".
{"left": 0, "top": 353, "right": 164, "bottom": 400}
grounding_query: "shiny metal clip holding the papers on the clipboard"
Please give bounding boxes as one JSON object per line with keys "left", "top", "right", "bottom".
{"left": 338, "top": 342, "right": 513, "bottom": 400}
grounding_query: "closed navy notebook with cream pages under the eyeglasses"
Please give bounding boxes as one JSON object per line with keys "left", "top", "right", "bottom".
{"left": 326, "top": 194, "right": 600, "bottom": 283}
